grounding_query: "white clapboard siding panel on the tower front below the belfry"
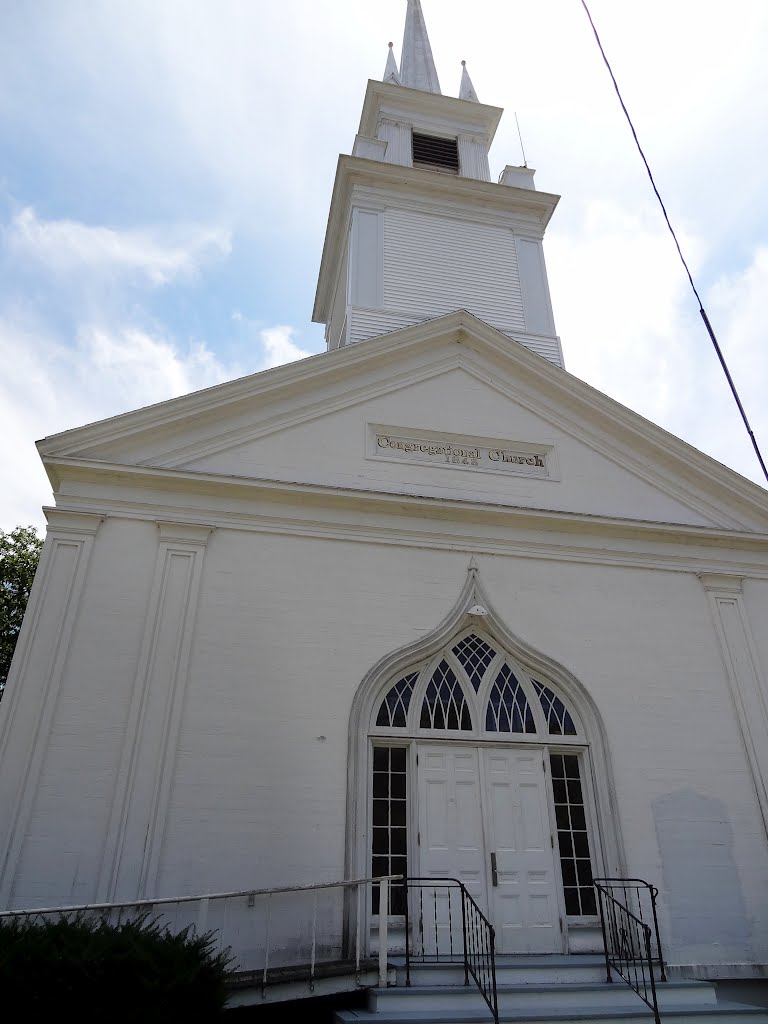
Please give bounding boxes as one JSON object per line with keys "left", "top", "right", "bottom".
{"left": 384, "top": 209, "right": 525, "bottom": 331}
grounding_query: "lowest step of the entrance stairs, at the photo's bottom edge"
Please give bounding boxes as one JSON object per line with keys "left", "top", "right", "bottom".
{"left": 335, "top": 999, "right": 768, "bottom": 1024}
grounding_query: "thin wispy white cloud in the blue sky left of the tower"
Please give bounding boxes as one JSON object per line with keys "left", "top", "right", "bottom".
{"left": 5, "top": 207, "right": 231, "bottom": 286}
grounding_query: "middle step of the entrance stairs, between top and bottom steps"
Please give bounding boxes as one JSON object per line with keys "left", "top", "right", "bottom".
{"left": 368, "top": 980, "right": 717, "bottom": 1014}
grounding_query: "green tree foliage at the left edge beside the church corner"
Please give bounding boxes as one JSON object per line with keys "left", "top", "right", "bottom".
{"left": 0, "top": 526, "right": 43, "bottom": 696}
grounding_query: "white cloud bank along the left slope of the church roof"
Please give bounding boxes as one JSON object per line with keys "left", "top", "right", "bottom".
{"left": 0, "top": 311, "right": 310, "bottom": 529}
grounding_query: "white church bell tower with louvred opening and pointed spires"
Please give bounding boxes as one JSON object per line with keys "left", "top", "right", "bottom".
{"left": 312, "top": 0, "right": 563, "bottom": 366}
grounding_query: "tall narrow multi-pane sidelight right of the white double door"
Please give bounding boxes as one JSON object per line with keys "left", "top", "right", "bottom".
{"left": 549, "top": 754, "right": 597, "bottom": 916}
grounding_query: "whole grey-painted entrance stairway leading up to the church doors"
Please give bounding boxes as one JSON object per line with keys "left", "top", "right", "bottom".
{"left": 335, "top": 954, "right": 768, "bottom": 1024}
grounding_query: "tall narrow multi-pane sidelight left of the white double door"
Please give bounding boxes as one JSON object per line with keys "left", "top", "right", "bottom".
{"left": 371, "top": 749, "right": 409, "bottom": 913}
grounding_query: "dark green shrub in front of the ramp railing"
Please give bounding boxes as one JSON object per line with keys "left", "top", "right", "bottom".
{"left": 0, "top": 914, "right": 230, "bottom": 1024}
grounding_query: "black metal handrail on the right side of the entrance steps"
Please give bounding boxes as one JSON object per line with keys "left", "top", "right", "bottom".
{"left": 593, "top": 879, "right": 667, "bottom": 1024}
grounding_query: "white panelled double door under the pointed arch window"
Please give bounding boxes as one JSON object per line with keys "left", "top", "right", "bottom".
{"left": 417, "top": 743, "right": 563, "bottom": 953}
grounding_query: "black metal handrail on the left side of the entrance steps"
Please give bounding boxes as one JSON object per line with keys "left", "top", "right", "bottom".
{"left": 404, "top": 878, "right": 499, "bottom": 1024}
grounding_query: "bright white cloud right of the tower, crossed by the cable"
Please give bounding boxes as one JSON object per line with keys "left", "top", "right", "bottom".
{"left": 547, "top": 202, "right": 768, "bottom": 483}
